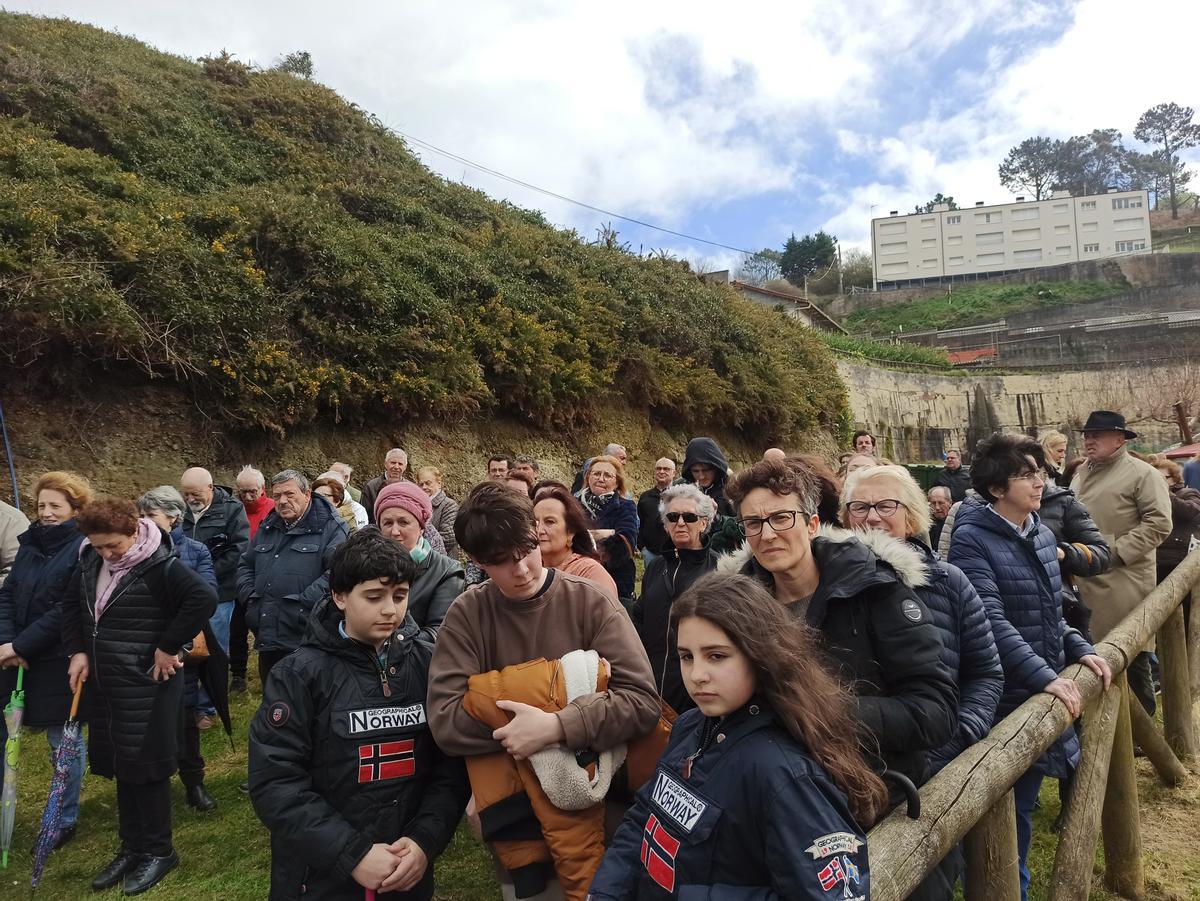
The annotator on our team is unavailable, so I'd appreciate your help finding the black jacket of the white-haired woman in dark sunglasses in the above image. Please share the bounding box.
[630,545,720,713]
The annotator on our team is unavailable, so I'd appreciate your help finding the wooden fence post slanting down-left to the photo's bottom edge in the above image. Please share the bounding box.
[1050,686,1121,901]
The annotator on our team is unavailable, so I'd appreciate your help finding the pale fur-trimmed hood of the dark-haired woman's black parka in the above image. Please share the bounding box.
[716,523,929,596]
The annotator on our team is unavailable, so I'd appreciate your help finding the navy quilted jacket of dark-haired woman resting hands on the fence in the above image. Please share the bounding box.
[950,497,1094,779]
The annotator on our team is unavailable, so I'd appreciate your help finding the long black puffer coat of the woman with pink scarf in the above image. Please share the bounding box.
[62,533,217,783]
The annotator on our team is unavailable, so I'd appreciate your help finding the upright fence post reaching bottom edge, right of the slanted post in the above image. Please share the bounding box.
[1100,672,1146,899]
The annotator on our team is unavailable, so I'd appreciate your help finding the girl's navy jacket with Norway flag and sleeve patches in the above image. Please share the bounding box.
[588,701,871,901]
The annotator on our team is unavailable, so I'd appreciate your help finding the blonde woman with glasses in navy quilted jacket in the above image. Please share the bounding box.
[841,464,1004,773]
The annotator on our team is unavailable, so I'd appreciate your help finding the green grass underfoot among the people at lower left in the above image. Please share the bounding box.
[0,661,500,901]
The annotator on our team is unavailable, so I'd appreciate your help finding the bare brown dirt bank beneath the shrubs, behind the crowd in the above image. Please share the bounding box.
[0,385,833,513]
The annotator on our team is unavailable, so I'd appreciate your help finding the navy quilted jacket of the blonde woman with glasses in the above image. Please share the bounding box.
[908,541,1004,773]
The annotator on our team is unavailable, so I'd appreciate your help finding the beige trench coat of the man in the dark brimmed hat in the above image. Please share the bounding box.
[1070,449,1171,641]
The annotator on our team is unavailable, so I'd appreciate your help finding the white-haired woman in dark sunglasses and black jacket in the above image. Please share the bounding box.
[630,482,720,713]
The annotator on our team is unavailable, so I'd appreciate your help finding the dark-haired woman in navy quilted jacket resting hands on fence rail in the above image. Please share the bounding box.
[949,434,1112,901]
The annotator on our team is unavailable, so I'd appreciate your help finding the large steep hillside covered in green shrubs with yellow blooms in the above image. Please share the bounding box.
[0,13,846,439]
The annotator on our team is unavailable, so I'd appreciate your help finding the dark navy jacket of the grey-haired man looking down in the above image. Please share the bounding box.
[238,494,347,651]
